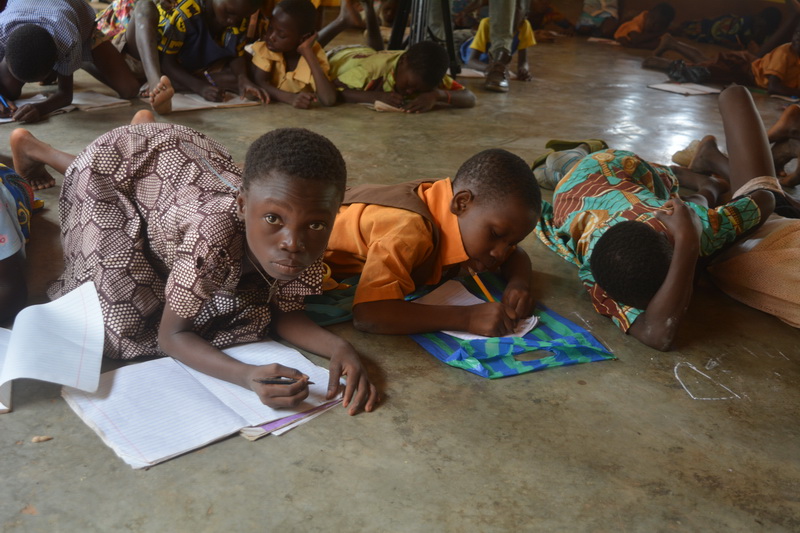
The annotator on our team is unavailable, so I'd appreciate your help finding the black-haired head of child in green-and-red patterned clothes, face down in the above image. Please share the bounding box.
[589,220,672,309]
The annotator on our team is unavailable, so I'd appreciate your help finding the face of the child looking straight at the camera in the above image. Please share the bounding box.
[237,172,341,281]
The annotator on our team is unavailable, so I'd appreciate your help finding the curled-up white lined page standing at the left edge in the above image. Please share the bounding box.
[0,282,104,391]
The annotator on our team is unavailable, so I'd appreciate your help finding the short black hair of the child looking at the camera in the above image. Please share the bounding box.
[242,128,347,200]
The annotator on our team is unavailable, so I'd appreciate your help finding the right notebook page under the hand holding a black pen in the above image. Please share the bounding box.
[178,340,329,427]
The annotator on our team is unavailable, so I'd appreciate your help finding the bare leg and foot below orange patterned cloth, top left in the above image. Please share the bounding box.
[97,0,175,115]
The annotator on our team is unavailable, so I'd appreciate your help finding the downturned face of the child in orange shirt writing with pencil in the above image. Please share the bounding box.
[450,191,539,271]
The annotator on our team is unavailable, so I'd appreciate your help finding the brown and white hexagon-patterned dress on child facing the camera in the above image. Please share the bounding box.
[48,124,322,359]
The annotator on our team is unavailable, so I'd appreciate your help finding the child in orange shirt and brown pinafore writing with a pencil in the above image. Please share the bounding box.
[325,149,541,336]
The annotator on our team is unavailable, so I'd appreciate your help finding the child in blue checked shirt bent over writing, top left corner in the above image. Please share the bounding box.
[0,0,139,125]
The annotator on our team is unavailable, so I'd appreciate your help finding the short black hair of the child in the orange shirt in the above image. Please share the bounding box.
[453,148,542,216]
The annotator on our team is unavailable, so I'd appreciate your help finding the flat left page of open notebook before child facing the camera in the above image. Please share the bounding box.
[62,357,245,468]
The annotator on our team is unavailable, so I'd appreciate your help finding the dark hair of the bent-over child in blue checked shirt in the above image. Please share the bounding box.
[6,24,58,83]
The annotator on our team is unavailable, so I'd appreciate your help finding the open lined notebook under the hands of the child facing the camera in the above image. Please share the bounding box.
[62,341,339,468]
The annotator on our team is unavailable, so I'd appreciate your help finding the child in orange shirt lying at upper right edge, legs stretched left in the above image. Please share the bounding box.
[642,25,800,96]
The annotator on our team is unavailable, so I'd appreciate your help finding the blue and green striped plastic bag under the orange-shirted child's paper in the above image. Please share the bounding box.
[306,274,615,379]
